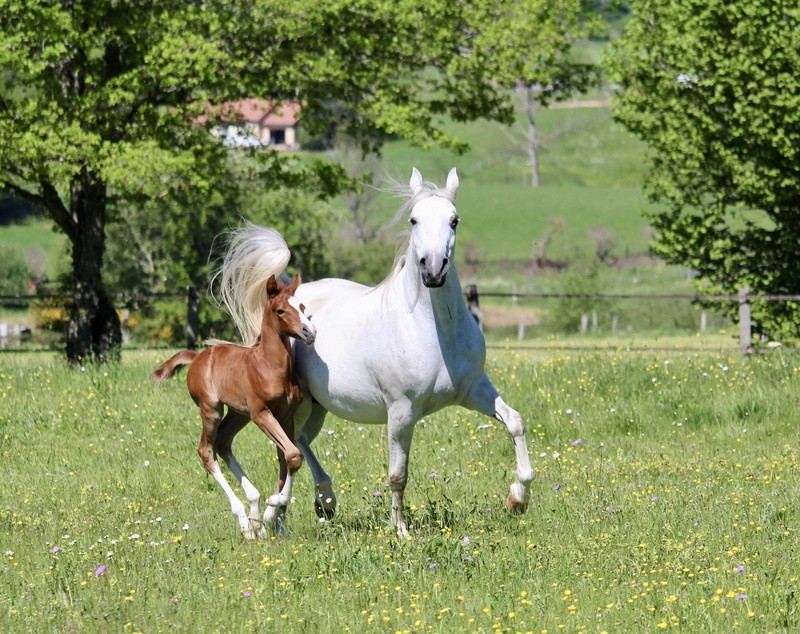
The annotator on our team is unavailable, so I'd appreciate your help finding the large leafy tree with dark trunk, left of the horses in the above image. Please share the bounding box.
[0,0,510,362]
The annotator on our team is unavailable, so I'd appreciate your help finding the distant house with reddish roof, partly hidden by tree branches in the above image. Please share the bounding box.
[197,98,300,150]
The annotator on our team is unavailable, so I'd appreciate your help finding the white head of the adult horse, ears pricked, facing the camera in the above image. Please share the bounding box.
[409,167,458,288]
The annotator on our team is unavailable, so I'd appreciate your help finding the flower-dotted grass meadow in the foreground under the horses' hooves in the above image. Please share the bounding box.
[0,347,800,632]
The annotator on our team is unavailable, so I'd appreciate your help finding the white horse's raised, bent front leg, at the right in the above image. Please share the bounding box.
[463,374,536,513]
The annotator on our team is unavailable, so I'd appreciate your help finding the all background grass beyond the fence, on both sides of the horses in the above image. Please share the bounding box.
[0,102,692,339]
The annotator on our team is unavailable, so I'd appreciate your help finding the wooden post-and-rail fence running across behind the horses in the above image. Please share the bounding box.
[0,284,800,355]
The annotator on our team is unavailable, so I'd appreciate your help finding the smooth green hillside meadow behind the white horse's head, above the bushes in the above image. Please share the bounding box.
[373,103,651,270]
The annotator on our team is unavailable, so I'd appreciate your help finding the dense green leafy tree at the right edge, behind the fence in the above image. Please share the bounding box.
[609,0,800,338]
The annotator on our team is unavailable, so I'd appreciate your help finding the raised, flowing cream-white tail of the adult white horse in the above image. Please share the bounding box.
[215,222,291,345]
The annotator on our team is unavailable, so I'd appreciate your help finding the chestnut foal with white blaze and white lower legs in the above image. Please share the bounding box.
[151,275,316,539]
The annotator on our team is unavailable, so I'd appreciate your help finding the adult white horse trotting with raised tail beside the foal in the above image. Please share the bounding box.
[221,168,534,538]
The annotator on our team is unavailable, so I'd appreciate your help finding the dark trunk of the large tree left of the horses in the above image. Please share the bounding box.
[66,168,122,363]
